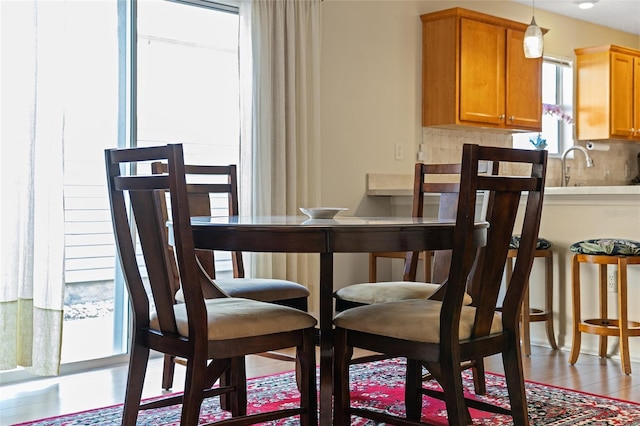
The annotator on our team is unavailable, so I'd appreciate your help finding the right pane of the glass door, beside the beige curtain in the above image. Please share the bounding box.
[136,1,240,277]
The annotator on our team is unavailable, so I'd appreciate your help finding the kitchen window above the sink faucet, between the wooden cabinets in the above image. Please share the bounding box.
[513,57,574,154]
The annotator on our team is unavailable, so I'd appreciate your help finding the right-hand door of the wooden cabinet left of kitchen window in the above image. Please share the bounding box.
[506,30,542,131]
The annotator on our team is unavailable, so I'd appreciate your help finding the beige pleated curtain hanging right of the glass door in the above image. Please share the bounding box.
[240,0,321,306]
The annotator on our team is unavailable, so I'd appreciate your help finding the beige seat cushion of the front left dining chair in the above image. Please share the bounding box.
[150,298,317,340]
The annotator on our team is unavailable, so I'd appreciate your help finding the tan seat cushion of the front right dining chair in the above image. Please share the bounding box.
[334,299,502,343]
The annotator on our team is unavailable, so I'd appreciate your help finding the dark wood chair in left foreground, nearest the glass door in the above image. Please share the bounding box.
[105,145,317,426]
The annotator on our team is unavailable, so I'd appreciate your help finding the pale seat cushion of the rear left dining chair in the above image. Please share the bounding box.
[176,278,309,302]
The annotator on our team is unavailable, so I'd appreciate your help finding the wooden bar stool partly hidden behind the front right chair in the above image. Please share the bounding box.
[506,235,558,356]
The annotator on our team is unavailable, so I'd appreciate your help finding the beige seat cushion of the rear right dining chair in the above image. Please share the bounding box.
[336,281,472,305]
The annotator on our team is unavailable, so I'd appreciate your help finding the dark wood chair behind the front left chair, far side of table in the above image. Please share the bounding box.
[151,161,309,389]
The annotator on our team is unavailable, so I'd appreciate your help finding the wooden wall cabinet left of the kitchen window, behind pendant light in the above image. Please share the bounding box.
[421,8,542,132]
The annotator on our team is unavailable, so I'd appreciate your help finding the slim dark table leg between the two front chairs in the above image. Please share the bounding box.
[320,253,333,426]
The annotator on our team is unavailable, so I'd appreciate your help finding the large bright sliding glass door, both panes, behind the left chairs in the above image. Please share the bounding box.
[62,0,240,363]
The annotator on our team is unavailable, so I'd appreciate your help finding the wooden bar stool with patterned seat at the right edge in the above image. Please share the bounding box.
[569,239,640,374]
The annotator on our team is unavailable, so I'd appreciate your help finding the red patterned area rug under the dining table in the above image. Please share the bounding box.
[13,359,640,426]
